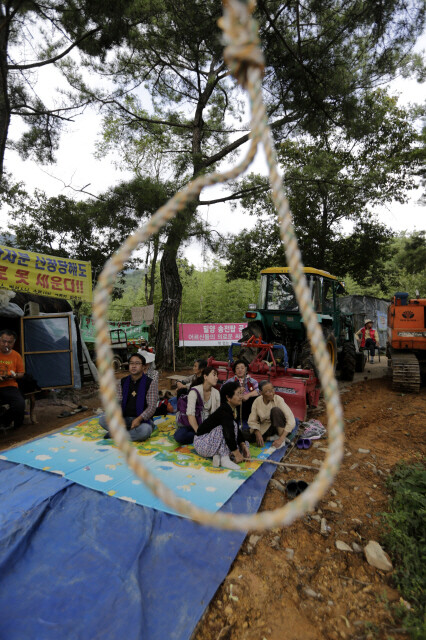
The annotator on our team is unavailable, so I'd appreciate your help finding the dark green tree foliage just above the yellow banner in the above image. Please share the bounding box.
[4,178,172,297]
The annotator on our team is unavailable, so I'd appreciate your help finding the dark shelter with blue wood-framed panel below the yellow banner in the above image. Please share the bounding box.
[0,291,89,389]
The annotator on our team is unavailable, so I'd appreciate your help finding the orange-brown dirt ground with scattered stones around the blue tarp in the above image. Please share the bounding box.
[0,357,426,640]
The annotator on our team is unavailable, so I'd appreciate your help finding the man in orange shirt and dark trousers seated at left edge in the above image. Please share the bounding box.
[0,329,25,429]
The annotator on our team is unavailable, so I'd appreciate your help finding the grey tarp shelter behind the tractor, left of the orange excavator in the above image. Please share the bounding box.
[339,296,390,347]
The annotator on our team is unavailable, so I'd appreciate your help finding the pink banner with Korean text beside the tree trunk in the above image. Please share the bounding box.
[179,322,247,347]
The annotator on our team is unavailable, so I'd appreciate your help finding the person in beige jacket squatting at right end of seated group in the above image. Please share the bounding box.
[248,380,296,449]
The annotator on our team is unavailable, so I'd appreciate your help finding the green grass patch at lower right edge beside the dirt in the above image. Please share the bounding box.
[382,462,426,640]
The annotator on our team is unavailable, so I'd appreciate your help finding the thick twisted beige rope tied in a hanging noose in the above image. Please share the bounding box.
[93,0,343,531]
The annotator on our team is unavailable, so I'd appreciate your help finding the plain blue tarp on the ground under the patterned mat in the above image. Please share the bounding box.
[0,449,284,640]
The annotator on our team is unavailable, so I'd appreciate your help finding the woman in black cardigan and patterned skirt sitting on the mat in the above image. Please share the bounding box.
[194,382,250,469]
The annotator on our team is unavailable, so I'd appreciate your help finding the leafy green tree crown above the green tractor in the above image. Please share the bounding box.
[225,89,423,287]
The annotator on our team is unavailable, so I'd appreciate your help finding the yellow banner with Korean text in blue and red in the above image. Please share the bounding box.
[0,245,92,302]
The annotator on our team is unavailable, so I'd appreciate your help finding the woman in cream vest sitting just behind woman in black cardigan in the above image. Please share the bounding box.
[174,367,220,444]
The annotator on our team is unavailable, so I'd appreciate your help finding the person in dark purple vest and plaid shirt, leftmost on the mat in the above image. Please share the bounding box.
[99,353,158,442]
